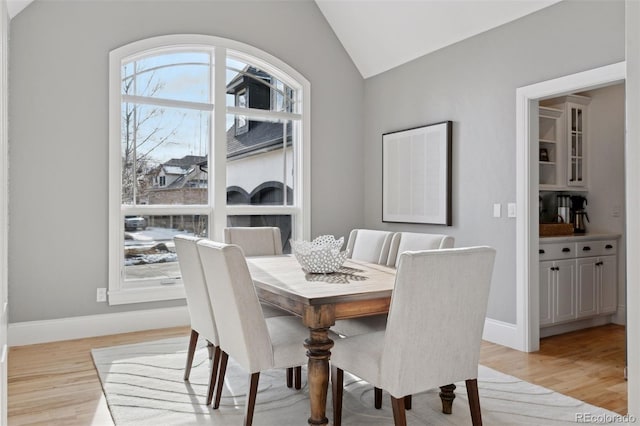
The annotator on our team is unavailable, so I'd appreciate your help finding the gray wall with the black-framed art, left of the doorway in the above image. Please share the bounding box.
[364,1,625,323]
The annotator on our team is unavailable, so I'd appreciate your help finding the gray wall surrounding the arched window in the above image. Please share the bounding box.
[9,0,364,322]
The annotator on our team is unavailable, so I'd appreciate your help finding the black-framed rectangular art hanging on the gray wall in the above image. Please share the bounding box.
[382,121,453,226]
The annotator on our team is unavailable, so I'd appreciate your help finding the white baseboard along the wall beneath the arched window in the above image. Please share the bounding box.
[7,306,190,346]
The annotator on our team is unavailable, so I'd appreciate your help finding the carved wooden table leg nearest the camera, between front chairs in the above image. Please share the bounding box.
[303,306,335,425]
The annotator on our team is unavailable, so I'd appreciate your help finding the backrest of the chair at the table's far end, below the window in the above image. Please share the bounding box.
[224,226,282,256]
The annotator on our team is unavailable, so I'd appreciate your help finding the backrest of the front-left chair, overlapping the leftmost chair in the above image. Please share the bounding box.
[198,240,273,373]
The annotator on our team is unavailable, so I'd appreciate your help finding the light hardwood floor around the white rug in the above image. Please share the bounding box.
[8,325,627,426]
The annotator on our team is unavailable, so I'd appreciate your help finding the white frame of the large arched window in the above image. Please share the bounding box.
[108,34,311,305]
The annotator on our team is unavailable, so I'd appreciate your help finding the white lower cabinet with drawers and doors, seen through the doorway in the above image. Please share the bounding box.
[539,238,618,327]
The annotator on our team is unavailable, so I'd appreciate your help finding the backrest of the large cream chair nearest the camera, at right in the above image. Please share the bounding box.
[381,247,495,397]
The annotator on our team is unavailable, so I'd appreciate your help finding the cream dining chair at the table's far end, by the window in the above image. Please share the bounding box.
[224,226,302,389]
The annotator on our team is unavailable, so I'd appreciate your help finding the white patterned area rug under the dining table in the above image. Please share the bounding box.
[92,336,623,426]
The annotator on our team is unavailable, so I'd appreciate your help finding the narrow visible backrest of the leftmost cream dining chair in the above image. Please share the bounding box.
[173,235,219,346]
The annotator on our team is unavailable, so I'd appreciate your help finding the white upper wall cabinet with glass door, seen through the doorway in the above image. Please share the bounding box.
[538,95,591,191]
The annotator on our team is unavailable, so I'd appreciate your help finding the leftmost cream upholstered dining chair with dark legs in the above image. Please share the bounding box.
[173,235,220,405]
